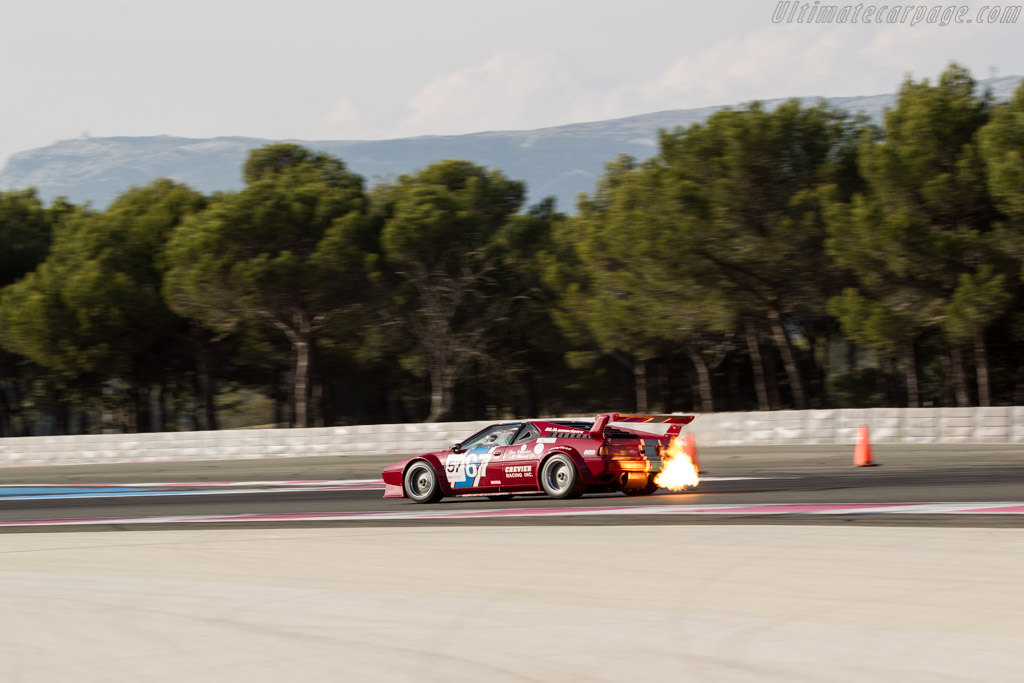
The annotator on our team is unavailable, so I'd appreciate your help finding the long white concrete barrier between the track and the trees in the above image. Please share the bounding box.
[0,405,1024,467]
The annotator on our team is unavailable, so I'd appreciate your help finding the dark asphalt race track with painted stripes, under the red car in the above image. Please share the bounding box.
[0,445,1024,532]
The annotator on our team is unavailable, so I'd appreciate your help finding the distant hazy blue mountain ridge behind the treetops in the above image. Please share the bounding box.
[0,76,1021,212]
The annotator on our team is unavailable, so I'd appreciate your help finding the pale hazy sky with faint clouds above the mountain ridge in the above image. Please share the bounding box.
[0,0,1024,161]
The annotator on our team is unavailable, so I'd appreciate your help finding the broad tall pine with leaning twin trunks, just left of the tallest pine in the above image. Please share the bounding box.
[660,100,862,409]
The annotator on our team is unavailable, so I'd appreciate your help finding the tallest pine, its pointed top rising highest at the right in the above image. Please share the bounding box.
[828,65,1004,407]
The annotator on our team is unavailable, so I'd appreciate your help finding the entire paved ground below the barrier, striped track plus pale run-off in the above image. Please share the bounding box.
[0,445,1024,683]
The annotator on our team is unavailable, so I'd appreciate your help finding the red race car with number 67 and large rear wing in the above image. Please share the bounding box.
[383,413,693,503]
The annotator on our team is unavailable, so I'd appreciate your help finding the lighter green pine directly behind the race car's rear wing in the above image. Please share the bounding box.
[548,157,735,412]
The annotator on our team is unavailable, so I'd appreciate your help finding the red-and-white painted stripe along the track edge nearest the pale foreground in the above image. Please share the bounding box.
[0,502,1024,527]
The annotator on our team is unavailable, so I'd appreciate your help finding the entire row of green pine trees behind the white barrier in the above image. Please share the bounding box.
[6,65,1024,435]
